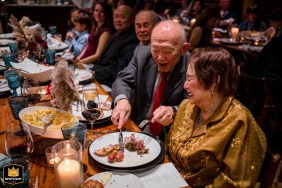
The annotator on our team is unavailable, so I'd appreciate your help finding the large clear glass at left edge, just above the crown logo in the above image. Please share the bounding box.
[5,121,34,157]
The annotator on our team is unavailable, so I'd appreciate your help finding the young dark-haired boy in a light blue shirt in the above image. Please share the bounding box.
[70,12,91,57]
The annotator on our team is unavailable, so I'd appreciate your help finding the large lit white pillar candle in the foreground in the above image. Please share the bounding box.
[58,160,83,188]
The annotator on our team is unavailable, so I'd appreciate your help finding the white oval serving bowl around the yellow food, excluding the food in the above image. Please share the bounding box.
[19,106,78,139]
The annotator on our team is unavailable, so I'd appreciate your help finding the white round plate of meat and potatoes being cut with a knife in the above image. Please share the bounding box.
[89,132,161,168]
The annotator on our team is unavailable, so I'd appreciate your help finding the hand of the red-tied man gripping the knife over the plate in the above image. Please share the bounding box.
[111,99,131,129]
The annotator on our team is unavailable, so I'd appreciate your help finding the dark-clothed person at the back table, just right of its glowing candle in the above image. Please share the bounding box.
[239,4,266,31]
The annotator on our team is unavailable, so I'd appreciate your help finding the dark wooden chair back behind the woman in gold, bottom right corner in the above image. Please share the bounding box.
[258,151,281,188]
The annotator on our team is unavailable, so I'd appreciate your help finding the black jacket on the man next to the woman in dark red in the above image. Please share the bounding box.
[93,26,139,87]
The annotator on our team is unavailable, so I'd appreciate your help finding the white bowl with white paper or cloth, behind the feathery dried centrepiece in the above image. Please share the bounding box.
[11,58,54,83]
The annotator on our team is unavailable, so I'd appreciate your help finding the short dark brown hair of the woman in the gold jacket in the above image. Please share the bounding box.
[188,47,239,96]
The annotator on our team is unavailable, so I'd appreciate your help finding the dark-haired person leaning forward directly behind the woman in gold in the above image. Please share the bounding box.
[188,7,220,51]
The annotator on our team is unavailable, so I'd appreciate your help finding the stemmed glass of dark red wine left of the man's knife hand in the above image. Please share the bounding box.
[81,88,101,130]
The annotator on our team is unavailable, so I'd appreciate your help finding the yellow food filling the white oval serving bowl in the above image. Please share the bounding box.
[22,109,75,130]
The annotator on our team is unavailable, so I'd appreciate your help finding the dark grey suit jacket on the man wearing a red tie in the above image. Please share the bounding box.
[112,46,187,124]
